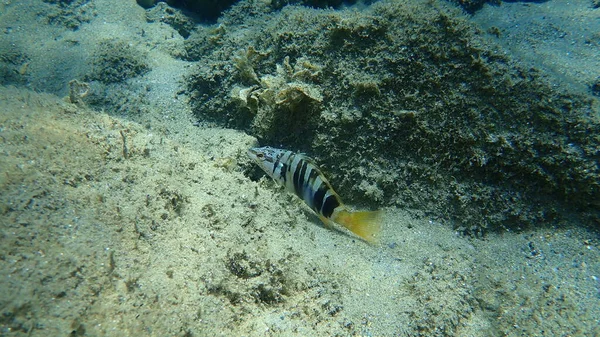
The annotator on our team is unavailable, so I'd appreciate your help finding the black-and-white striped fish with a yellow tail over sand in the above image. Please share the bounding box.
[248,147,381,243]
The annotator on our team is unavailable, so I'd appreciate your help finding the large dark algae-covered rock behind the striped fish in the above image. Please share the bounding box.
[186,1,600,234]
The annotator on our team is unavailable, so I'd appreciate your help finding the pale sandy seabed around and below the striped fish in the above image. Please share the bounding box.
[0,0,600,336]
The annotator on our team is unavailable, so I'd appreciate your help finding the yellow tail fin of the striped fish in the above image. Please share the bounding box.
[332,209,382,243]
